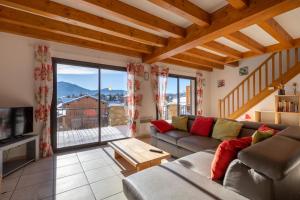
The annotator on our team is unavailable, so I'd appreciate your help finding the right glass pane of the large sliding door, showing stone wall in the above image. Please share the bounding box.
[100,69,129,142]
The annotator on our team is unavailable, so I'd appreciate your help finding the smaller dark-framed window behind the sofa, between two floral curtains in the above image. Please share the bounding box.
[163,75,196,120]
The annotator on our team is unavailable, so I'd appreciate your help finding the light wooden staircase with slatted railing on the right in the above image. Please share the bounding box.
[218,48,300,119]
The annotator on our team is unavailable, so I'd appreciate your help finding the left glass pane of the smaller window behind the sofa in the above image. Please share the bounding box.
[164,77,178,120]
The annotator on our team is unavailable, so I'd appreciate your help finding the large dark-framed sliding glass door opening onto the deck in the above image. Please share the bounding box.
[52,59,129,149]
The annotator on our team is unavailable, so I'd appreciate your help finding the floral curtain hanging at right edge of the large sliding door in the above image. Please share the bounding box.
[127,63,144,137]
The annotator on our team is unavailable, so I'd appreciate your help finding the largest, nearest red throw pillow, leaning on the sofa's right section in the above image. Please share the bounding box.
[210,137,252,180]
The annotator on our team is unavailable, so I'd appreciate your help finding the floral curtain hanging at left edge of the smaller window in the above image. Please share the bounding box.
[150,65,169,119]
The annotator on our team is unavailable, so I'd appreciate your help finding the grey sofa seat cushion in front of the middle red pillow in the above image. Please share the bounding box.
[177,135,221,152]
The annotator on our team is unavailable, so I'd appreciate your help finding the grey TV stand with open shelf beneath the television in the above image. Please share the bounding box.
[0,134,39,181]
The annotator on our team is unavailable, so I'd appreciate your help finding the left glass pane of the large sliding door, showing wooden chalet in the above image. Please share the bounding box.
[56,64,99,148]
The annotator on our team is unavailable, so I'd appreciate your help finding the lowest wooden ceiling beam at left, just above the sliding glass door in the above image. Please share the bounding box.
[0,21,141,57]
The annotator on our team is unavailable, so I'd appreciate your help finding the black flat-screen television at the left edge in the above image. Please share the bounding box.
[0,107,33,140]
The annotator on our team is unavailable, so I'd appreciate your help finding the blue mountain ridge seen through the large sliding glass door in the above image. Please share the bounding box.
[57,81,126,98]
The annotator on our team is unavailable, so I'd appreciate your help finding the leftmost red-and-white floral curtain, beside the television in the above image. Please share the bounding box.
[34,45,53,157]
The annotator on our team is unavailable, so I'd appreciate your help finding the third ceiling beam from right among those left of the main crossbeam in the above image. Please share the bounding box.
[80,0,185,38]
